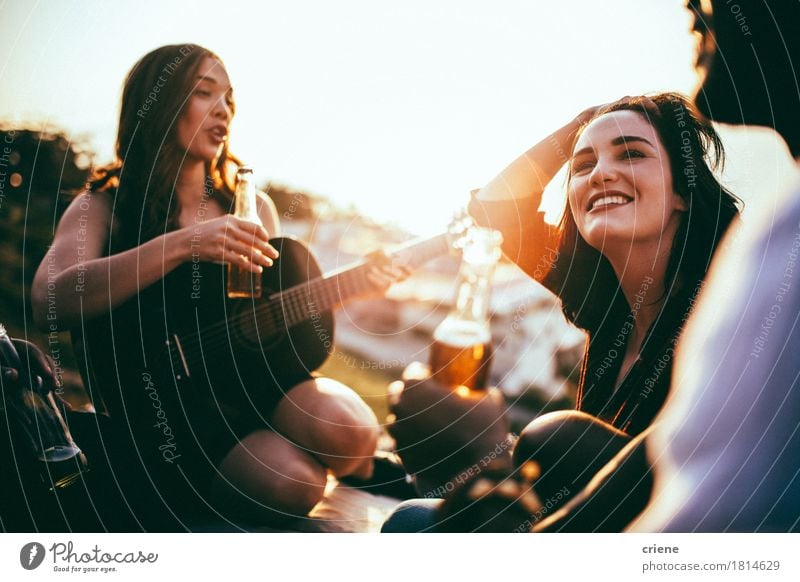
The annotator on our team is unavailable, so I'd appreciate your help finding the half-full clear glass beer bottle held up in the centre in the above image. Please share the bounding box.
[430,227,503,390]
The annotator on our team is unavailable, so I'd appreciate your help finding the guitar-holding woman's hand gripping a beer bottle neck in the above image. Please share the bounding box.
[186,214,278,273]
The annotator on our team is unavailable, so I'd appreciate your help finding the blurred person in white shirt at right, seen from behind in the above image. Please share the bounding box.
[385,0,800,532]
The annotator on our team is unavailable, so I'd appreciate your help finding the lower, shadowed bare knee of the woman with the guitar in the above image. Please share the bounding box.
[211,430,327,521]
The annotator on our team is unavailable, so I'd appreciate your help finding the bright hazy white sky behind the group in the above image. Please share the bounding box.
[0,0,788,233]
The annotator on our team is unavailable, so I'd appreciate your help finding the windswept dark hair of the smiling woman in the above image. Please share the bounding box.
[547,93,739,333]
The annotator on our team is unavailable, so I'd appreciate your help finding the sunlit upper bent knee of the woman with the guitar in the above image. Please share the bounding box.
[272,378,380,479]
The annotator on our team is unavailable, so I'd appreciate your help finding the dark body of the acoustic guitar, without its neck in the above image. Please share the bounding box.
[73,238,334,419]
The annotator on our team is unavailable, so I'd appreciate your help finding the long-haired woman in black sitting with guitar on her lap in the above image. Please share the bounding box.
[32,44,396,521]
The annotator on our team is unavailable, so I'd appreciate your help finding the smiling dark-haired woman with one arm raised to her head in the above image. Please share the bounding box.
[471,93,737,434]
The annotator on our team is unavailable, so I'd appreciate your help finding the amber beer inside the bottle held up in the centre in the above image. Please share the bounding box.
[430,322,492,390]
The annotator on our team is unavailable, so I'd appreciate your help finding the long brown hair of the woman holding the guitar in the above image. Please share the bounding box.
[89,44,239,246]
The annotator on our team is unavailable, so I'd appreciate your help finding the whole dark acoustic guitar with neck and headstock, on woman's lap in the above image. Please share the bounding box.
[72,228,451,460]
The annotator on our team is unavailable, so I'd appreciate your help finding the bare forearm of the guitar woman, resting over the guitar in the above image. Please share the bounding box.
[32,231,190,330]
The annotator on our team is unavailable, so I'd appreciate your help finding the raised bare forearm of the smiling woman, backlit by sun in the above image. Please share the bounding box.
[476,114,585,207]
